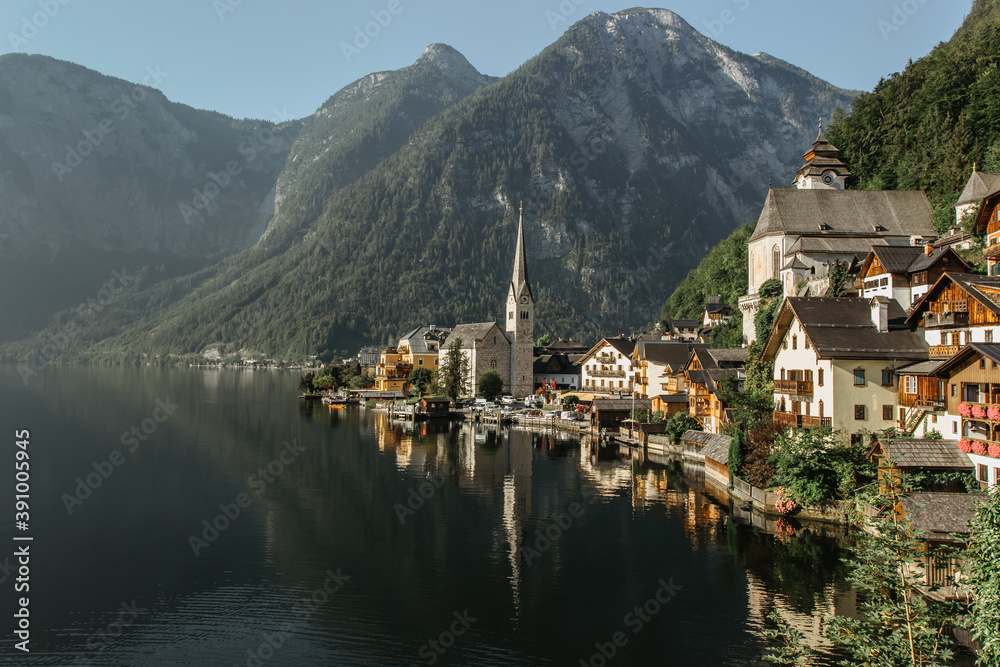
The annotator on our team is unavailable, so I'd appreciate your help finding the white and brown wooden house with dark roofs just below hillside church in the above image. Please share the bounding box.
[856,245,969,310]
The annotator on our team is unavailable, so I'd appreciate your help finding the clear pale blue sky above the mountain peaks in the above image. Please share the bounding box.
[0,0,971,119]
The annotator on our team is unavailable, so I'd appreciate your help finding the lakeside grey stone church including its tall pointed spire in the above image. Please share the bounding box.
[439,207,535,398]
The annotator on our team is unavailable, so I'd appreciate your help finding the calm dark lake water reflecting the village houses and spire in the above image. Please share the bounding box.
[0,367,853,667]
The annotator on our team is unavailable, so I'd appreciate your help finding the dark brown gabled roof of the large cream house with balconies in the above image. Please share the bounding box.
[762,296,929,361]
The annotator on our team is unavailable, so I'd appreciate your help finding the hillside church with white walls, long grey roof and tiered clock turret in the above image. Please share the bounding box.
[739,132,937,342]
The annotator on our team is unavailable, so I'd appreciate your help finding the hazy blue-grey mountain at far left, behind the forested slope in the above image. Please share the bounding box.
[0,54,299,339]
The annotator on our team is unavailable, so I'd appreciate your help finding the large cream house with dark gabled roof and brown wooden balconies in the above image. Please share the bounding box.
[762,297,927,439]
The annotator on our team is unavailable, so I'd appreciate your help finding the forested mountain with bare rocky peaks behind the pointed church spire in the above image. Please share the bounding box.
[3,9,853,366]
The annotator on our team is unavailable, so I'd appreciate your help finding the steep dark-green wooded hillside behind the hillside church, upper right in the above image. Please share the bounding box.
[827,0,1000,232]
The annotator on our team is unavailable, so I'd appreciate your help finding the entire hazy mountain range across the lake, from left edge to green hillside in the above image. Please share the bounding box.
[0,9,853,360]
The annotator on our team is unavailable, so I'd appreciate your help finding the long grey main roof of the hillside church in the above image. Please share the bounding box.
[750,189,937,241]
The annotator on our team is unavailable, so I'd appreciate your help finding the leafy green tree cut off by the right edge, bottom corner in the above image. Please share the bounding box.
[966,486,1000,667]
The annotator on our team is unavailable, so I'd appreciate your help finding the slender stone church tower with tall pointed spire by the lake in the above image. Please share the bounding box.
[505,204,535,398]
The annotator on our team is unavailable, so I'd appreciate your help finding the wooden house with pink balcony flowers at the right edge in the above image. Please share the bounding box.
[938,343,1000,487]
